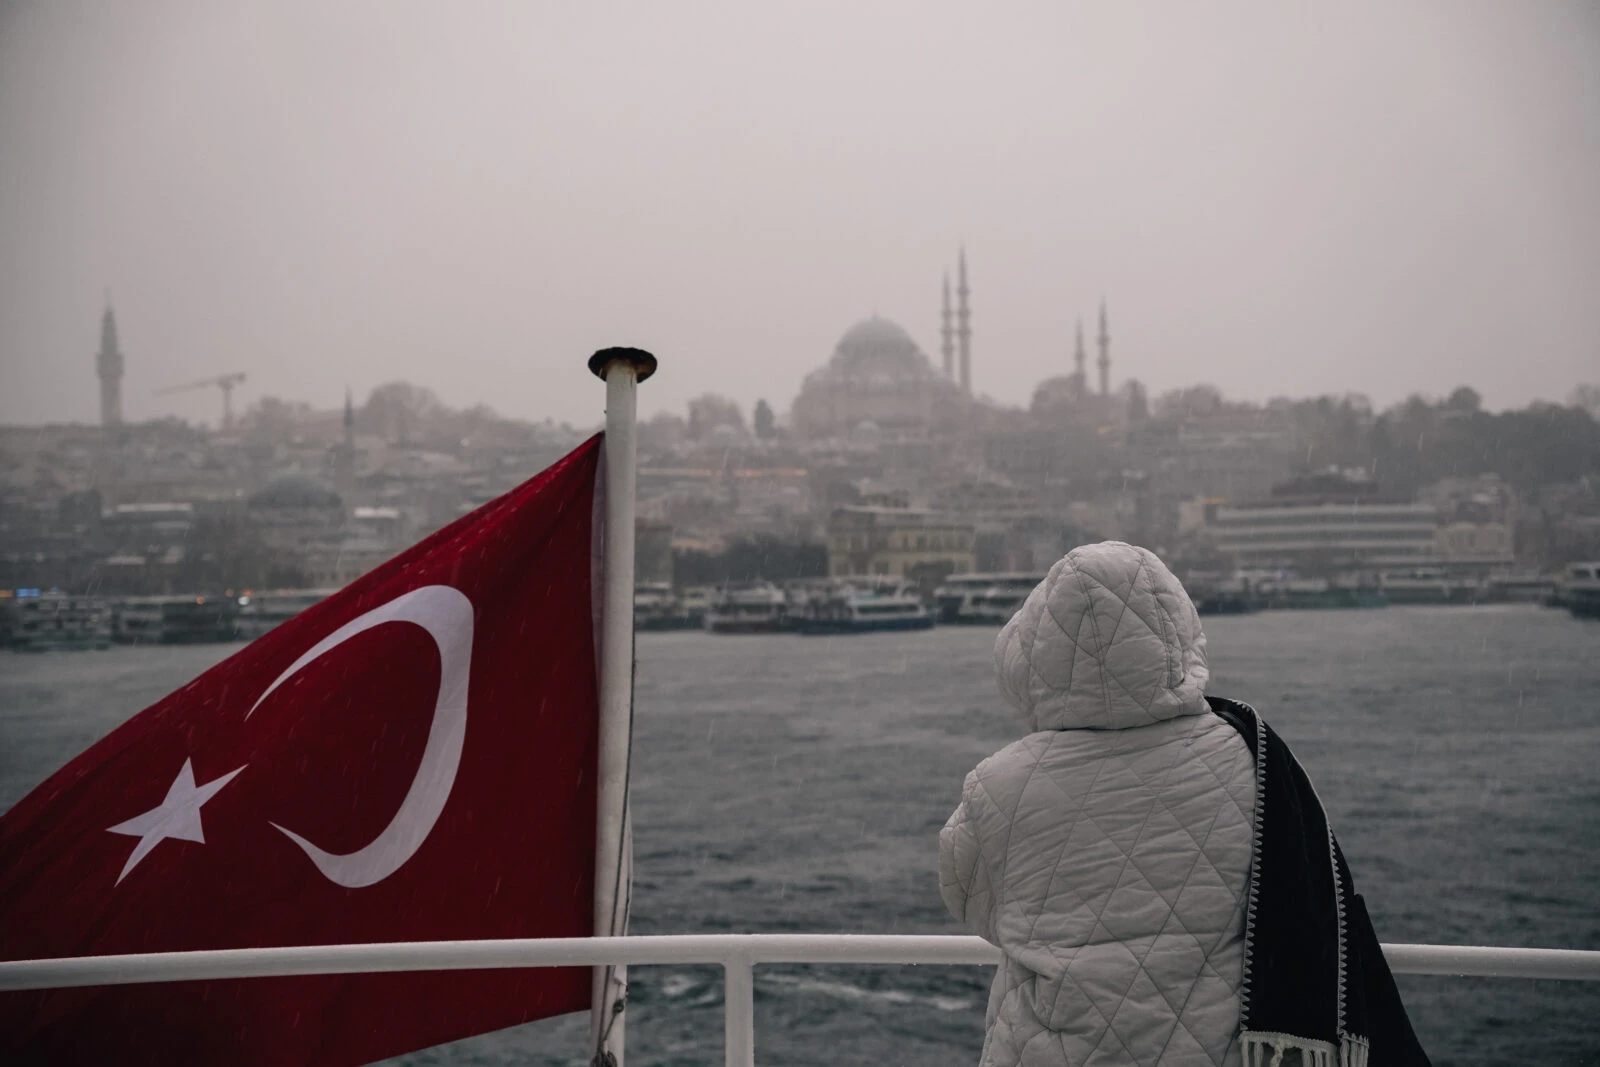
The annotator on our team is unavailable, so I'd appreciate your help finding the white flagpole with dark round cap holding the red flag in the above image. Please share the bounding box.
[589,349,656,1067]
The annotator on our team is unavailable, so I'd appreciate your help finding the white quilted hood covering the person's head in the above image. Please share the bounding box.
[995,541,1211,733]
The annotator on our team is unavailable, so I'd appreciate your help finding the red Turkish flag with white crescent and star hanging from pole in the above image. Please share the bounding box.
[0,435,602,1064]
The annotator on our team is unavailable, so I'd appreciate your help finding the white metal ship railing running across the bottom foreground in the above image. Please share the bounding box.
[0,934,1600,1067]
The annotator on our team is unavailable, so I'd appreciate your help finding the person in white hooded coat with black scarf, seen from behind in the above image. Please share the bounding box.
[939,542,1426,1067]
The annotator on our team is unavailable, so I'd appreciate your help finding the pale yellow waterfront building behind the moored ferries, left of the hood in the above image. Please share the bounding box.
[827,507,976,577]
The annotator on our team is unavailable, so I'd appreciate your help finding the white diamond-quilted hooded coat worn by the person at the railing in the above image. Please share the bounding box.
[939,541,1254,1067]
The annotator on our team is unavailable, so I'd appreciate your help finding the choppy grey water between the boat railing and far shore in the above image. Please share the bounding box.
[0,606,1600,1067]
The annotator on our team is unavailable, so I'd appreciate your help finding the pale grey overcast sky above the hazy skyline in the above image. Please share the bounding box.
[0,0,1600,424]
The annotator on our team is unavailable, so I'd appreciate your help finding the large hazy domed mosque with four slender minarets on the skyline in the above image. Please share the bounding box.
[790,248,1123,438]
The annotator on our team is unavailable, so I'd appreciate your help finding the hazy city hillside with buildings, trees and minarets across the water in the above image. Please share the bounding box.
[0,292,1600,620]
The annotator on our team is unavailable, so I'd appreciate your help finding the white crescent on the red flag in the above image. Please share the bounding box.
[245,585,472,889]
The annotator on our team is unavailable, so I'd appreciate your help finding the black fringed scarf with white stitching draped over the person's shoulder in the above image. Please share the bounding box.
[1206,696,1429,1067]
